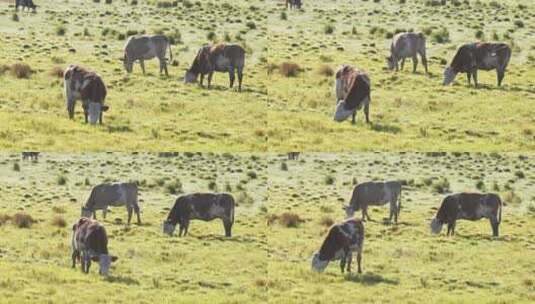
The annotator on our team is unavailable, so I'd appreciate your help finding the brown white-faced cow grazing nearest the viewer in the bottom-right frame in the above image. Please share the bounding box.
[312,219,364,273]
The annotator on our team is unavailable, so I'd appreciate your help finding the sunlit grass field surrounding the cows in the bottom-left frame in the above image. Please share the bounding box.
[0,153,267,303]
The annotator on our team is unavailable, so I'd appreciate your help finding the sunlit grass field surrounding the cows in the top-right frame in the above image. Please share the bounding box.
[267,0,535,152]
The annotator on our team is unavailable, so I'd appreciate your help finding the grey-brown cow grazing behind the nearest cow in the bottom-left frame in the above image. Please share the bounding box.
[82,183,141,225]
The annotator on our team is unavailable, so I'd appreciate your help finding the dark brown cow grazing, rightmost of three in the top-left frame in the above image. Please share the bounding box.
[184,44,245,91]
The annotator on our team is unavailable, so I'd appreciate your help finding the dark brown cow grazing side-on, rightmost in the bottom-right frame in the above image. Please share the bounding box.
[431,193,502,236]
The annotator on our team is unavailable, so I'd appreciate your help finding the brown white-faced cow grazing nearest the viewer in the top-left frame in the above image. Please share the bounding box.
[63,65,109,124]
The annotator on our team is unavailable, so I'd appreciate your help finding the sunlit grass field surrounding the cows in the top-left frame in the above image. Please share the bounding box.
[0,0,267,152]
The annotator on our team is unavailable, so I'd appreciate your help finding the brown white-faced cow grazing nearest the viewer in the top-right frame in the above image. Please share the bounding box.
[334,65,371,124]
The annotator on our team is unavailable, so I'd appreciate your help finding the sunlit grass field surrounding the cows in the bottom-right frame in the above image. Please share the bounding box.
[268,153,535,303]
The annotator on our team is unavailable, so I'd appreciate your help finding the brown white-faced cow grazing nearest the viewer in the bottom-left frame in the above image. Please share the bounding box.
[72,217,117,275]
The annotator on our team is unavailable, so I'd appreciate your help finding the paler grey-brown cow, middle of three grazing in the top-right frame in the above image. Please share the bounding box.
[386,33,428,73]
